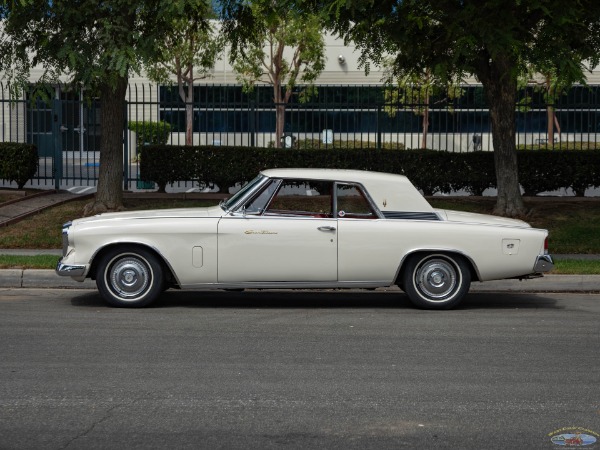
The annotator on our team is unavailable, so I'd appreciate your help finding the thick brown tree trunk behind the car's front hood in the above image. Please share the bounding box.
[83,77,127,216]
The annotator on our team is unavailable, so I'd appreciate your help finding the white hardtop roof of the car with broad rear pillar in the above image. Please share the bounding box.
[261,169,433,212]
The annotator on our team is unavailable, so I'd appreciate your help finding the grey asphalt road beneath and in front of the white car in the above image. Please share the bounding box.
[0,289,600,449]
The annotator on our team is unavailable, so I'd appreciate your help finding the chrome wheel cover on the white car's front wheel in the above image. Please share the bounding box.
[105,255,153,301]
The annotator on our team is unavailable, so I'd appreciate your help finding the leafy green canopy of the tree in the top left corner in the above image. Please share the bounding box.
[0,0,211,90]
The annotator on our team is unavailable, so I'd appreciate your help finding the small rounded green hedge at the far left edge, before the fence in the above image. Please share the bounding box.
[0,142,38,189]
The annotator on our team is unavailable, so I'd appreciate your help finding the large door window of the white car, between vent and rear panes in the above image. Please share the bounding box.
[265,180,333,217]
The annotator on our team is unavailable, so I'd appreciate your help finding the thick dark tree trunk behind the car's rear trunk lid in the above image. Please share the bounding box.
[477,55,526,217]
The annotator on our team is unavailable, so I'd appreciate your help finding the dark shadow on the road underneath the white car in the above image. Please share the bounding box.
[71,290,563,311]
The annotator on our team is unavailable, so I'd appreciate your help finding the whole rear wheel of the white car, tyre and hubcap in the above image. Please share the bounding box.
[400,253,471,309]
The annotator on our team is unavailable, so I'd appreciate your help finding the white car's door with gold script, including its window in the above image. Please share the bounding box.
[218,180,337,283]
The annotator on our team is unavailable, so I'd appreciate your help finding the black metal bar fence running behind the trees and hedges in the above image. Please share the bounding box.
[0,84,600,189]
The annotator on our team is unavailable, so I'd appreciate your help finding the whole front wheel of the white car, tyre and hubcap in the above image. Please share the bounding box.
[96,247,165,308]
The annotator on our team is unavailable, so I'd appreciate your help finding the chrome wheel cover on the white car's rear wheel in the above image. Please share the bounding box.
[414,257,461,302]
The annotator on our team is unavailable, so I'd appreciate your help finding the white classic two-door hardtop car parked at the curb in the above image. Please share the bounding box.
[56,169,553,309]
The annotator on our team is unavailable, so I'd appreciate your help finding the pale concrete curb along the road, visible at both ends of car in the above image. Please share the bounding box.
[0,269,600,293]
